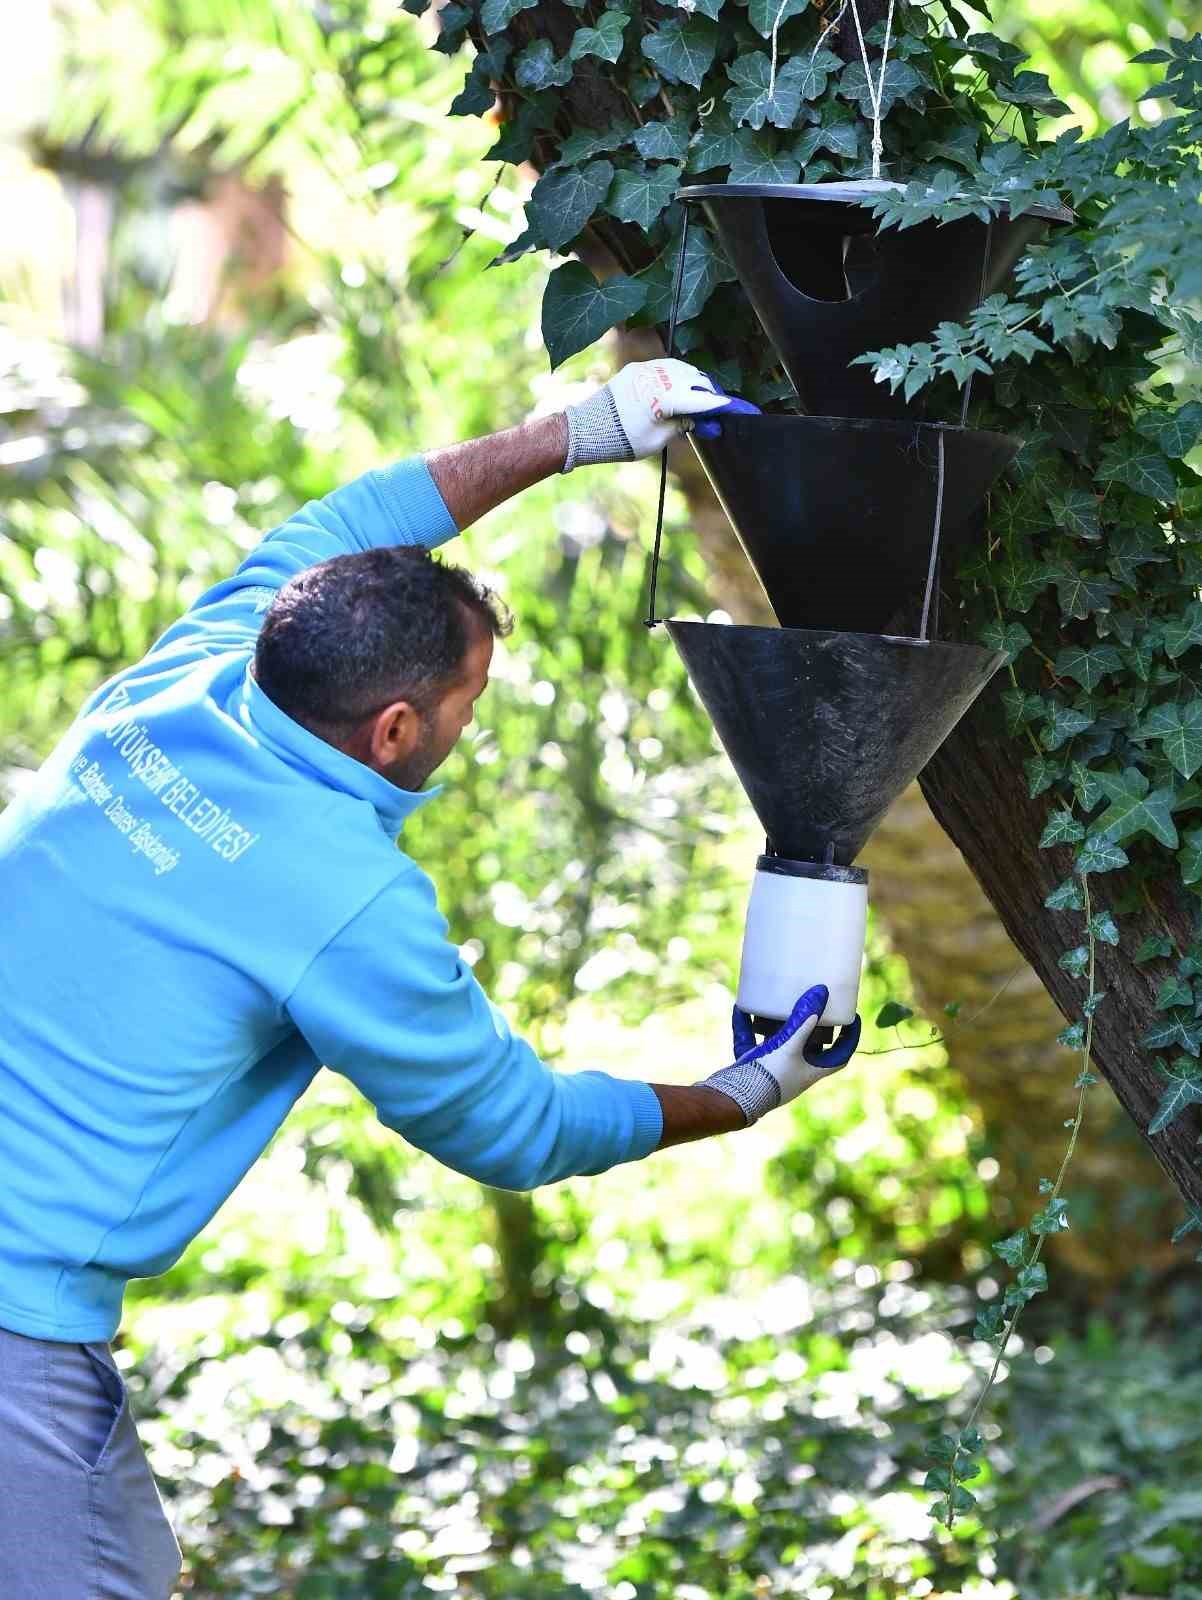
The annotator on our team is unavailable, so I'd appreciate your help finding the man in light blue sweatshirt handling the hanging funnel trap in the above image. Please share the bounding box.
[0,360,853,1600]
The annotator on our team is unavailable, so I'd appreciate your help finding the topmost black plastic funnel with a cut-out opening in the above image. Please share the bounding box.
[677,179,1072,418]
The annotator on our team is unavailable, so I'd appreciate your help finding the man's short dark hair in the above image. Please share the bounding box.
[254,546,512,730]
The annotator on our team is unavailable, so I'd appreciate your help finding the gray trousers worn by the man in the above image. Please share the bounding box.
[0,1328,179,1600]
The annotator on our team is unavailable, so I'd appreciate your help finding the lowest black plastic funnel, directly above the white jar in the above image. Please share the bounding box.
[667,621,1005,866]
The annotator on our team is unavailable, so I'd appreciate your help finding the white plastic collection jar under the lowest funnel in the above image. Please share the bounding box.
[738,856,867,1027]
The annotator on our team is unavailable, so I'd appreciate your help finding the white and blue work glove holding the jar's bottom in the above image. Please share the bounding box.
[699,984,859,1126]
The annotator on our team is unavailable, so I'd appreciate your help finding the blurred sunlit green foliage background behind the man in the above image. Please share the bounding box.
[0,0,1202,1600]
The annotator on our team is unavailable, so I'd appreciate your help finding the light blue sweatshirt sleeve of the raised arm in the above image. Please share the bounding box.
[142,456,459,656]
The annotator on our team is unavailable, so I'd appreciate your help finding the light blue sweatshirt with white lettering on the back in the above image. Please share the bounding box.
[0,461,663,1341]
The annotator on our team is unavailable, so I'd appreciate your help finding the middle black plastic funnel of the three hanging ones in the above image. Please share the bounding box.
[690,416,1021,634]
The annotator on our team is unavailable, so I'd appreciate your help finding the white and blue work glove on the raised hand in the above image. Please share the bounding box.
[563,357,759,472]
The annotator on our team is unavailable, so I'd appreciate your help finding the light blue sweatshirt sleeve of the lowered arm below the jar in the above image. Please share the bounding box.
[288,864,663,1189]
